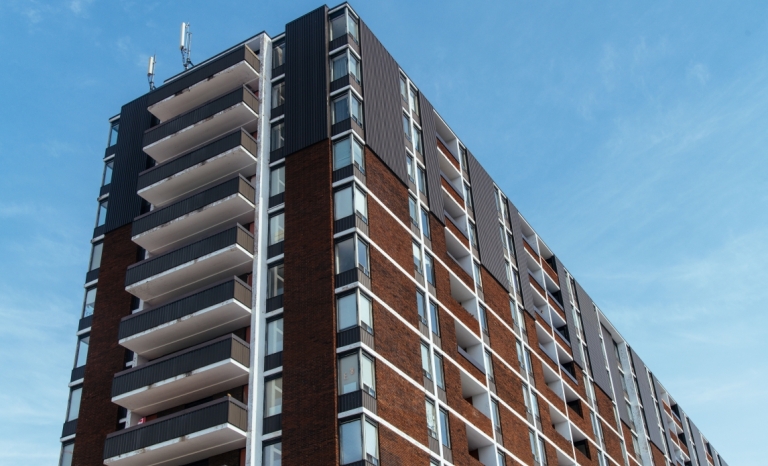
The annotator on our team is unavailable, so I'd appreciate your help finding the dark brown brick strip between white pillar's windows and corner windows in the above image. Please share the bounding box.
[282,140,338,466]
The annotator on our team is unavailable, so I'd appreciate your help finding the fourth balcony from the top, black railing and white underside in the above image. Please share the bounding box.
[131,175,256,254]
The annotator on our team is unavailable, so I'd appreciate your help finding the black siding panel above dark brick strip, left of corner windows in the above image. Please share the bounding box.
[285,6,330,155]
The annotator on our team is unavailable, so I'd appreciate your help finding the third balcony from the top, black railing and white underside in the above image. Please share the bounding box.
[136,129,257,207]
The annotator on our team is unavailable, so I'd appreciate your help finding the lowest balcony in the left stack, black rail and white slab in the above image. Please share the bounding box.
[104,397,248,466]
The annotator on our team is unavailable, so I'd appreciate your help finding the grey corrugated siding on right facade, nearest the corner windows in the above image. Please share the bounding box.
[360,21,408,185]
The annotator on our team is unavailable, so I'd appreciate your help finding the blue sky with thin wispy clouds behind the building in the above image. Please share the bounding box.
[0,0,768,465]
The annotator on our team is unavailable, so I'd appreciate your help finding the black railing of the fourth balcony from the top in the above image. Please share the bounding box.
[131,175,256,236]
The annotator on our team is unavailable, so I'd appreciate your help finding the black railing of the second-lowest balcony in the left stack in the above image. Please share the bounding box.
[112,334,250,397]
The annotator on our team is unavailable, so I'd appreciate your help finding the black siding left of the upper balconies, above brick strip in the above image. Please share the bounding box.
[105,95,152,232]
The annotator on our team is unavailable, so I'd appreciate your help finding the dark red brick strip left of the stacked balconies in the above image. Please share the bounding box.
[72,225,138,466]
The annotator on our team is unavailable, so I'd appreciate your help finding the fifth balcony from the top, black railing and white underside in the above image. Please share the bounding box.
[125,225,253,305]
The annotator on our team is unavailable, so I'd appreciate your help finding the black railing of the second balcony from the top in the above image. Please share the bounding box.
[144,86,259,151]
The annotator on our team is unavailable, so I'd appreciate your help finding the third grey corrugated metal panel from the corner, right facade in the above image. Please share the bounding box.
[467,151,510,290]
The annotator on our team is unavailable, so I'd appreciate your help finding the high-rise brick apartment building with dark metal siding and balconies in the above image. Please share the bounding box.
[60,3,727,466]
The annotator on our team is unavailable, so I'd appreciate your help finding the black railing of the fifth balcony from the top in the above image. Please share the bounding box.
[125,225,253,287]
